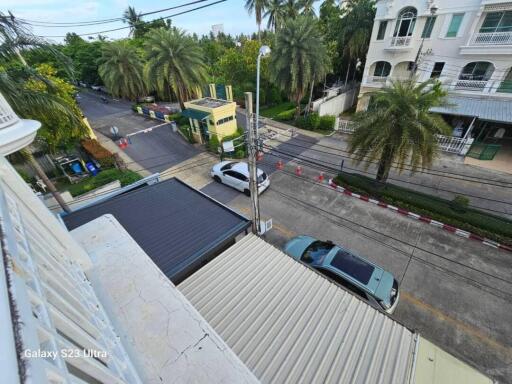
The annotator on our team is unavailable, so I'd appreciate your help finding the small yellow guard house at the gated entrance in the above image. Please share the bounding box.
[182,84,237,144]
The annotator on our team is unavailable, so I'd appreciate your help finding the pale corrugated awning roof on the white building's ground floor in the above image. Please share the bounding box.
[430,96,512,123]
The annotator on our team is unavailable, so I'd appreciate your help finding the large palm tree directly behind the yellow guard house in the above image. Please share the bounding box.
[144,28,207,109]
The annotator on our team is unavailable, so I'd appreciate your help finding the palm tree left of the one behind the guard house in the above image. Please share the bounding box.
[98,41,146,100]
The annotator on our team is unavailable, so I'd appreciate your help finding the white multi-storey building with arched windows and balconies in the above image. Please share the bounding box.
[358,0,512,172]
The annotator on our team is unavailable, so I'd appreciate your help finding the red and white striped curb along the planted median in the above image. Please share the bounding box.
[329,179,512,252]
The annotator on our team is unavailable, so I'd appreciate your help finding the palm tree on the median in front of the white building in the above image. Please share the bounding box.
[348,79,450,181]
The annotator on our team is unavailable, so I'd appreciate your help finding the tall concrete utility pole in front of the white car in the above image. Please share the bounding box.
[245,92,260,234]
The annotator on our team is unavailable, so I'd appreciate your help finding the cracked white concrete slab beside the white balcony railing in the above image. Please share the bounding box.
[72,215,258,384]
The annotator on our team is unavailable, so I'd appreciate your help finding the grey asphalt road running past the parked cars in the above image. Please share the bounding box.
[79,95,512,383]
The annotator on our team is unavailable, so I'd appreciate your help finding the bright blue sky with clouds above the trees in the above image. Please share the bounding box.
[0,0,286,42]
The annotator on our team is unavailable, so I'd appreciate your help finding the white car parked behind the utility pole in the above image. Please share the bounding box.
[211,161,270,196]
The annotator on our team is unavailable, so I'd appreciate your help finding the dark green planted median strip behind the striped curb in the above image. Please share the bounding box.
[334,173,512,245]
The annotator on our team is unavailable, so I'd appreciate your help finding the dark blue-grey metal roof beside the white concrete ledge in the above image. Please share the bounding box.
[63,178,250,283]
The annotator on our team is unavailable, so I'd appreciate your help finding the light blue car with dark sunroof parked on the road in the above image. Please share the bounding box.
[284,236,400,314]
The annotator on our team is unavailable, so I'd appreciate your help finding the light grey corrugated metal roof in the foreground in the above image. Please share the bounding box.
[178,235,415,384]
